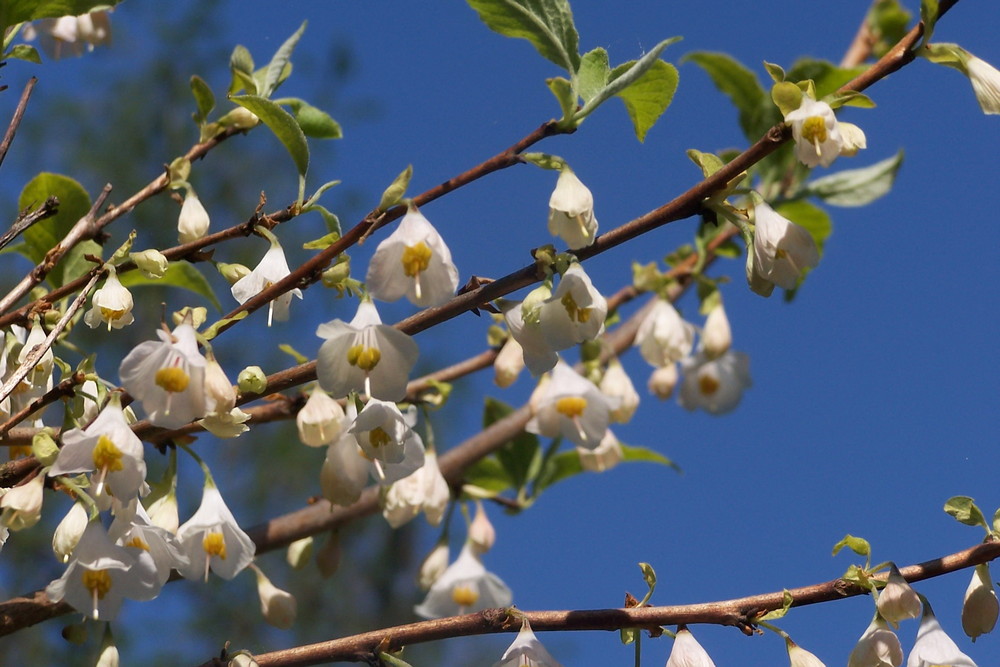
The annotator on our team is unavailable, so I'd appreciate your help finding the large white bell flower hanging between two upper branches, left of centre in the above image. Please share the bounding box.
[365,204,458,307]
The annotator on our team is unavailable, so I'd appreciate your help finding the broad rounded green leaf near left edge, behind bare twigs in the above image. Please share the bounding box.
[17,172,92,287]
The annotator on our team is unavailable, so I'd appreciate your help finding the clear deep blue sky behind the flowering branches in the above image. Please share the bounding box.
[3,0,1000,667]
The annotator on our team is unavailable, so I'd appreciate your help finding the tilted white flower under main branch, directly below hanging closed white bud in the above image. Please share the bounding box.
[538,262,608,350]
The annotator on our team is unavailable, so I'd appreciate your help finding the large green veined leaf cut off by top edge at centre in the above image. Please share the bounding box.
[468,0,580,74]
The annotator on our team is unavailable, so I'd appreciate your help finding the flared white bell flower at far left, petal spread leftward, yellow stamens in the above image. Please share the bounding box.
[49,394,146,503]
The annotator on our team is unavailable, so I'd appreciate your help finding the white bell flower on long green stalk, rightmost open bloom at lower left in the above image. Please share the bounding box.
[177,483,256,581]
